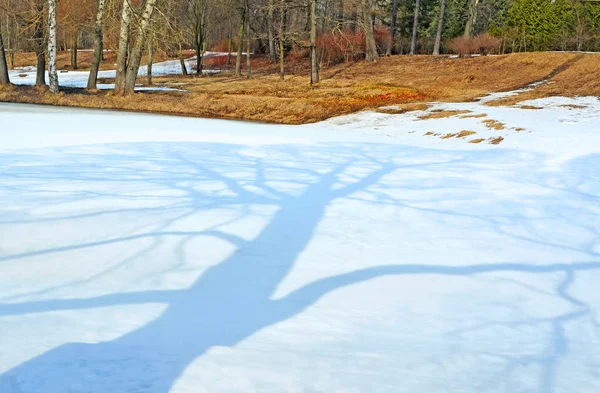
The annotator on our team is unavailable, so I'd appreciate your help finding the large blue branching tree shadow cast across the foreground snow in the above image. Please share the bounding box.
[0,144,600,393]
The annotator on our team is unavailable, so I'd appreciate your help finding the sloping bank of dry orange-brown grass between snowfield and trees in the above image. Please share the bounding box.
[0,52,600,124]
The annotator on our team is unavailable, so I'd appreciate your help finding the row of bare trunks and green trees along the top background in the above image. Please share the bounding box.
[0,0,600,94]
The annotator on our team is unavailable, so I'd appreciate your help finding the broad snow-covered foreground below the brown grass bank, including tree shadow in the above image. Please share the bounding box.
[0,98,600,393]
